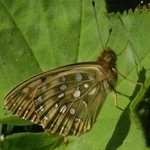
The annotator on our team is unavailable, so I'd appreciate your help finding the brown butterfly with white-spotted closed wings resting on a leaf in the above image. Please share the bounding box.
[4,48,118,136]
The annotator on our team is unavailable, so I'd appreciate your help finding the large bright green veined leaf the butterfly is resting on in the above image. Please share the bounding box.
[0,0,150,150]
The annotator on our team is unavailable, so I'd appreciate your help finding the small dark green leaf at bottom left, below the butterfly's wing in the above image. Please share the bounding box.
[0,133,63,150]
